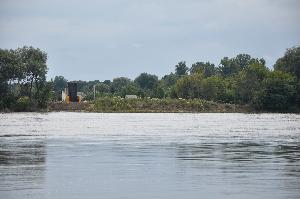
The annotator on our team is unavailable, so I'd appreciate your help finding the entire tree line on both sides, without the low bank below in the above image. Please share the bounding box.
[0,47,300,112]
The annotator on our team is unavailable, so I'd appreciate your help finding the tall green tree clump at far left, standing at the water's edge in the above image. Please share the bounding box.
[0,46,52,111]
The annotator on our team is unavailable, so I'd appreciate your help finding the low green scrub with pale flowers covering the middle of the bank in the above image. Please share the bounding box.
[90,97,247,113]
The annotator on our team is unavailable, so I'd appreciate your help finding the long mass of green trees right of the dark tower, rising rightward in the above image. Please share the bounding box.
[54,47,300,112]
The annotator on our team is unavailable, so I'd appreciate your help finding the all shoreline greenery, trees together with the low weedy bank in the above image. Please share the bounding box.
[0,46,300,112]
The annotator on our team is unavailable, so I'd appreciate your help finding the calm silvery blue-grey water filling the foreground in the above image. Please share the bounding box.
[0,113,300,199]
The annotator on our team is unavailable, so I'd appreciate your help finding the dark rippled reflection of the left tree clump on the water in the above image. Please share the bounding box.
[0,134,46,198]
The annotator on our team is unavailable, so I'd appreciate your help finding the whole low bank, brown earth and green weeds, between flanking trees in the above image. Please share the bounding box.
[49,97,254,113]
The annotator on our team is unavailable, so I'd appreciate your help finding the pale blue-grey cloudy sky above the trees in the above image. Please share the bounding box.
[0,0,300,81]
